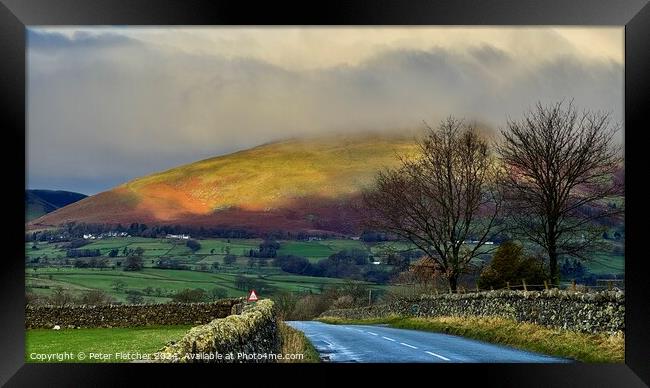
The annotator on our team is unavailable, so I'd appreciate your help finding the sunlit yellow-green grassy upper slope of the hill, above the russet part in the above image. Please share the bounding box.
[127,136,415,209]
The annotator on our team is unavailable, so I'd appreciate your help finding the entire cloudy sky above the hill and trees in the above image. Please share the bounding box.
[26,26,624,194]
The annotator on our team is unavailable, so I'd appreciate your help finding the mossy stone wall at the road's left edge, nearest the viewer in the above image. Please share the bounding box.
[157,299,281,363]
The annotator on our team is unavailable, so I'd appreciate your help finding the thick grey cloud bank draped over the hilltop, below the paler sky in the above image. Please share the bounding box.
[28,33,623,194]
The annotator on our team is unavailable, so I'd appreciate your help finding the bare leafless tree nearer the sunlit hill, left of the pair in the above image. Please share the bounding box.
[363,117,500,292]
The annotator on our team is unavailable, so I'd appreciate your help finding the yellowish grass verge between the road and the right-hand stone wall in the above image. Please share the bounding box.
[318,316,625,363]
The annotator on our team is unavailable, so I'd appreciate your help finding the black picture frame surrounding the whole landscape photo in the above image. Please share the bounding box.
[0,0,650,387]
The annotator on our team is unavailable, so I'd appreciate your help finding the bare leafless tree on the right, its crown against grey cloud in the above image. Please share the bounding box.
[498,102,623,283]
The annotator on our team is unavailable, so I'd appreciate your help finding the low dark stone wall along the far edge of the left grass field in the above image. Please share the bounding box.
[25,298,243,329]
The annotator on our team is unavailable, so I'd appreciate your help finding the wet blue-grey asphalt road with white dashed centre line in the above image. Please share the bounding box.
[287,321,571,363]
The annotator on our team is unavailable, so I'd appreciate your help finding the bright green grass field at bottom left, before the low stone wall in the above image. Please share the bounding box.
[25,325,191,363]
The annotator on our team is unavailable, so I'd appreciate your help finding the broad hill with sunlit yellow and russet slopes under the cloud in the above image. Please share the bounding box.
[30,134,415,233]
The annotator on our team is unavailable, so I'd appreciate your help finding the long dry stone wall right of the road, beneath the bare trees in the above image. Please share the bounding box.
[321,289,625,333]
